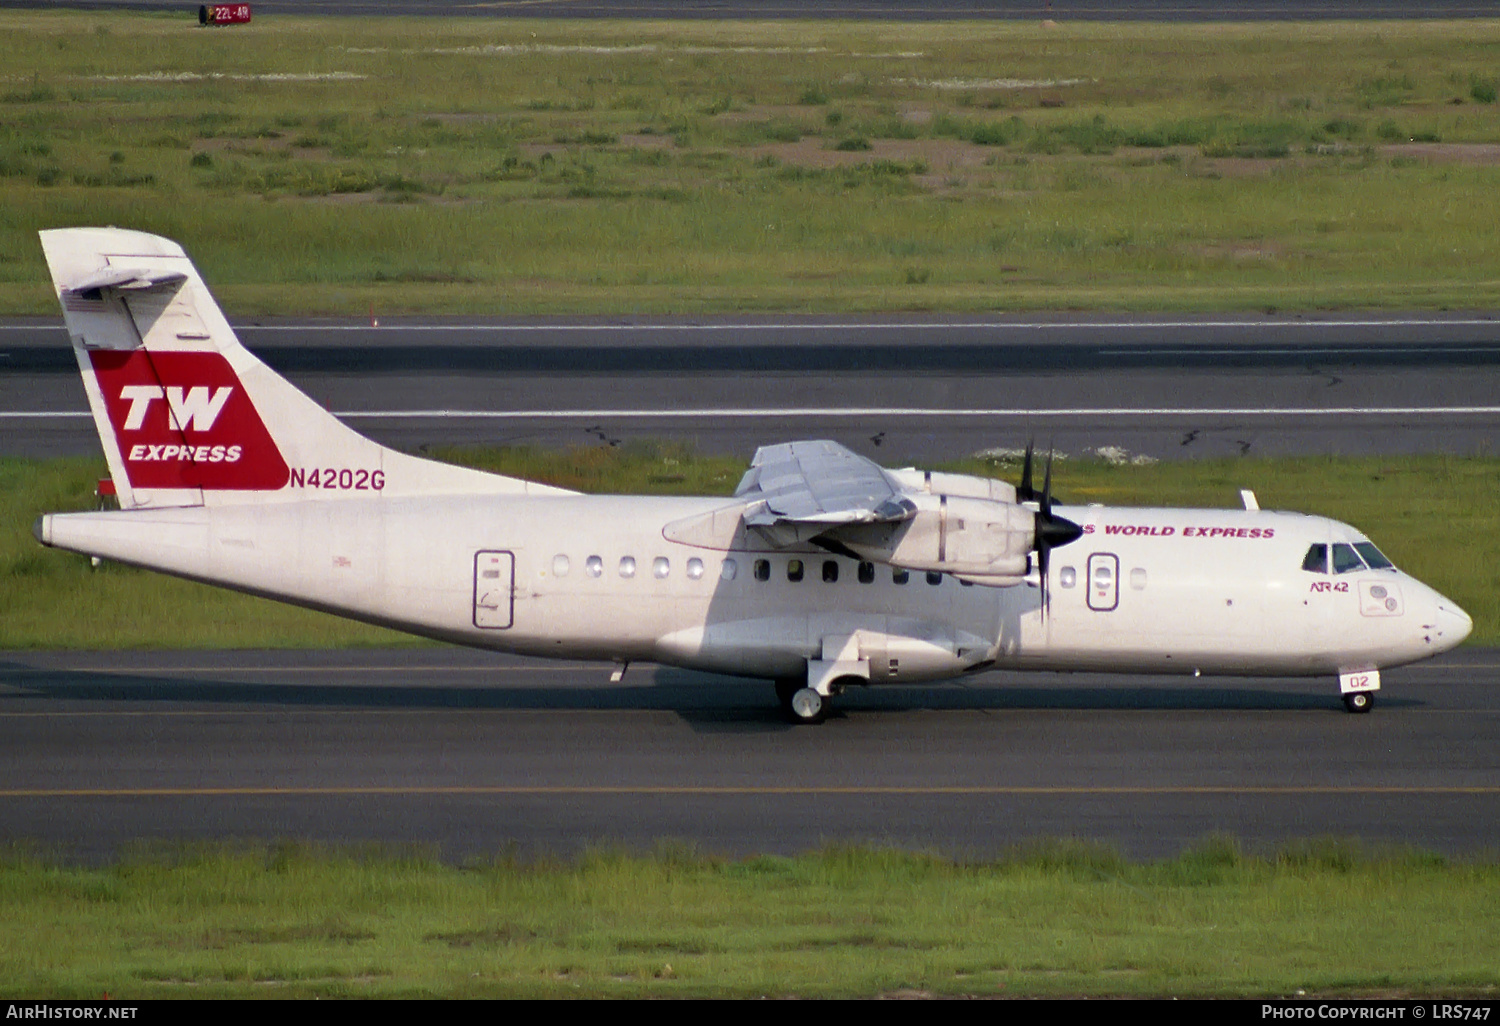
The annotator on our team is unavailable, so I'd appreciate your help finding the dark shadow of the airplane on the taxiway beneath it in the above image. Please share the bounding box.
[0,662,1404,732]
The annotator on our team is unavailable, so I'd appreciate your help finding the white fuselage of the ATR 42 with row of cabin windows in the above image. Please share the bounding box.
[39,495,1470,683]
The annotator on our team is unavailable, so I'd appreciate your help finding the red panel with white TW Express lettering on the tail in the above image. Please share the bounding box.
[89,350,290,491]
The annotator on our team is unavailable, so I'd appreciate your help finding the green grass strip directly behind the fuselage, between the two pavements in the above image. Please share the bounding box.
[0,446,1500,650]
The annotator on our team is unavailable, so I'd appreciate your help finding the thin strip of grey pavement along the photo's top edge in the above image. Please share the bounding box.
[0,0,1497,21]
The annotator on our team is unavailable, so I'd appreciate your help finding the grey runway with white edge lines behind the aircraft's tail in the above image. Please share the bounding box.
[0,312,1500,464]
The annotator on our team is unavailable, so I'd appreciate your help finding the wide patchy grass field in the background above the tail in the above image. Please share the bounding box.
[0,11,1500,315]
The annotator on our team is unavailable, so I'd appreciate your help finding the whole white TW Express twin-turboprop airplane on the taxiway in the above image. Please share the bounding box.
[36,228,1472,722]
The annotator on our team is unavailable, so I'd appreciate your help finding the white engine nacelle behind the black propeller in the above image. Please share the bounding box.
[831,492,1037,584]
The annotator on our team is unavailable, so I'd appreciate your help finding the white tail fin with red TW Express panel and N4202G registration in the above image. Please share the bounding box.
[41,228,563,509]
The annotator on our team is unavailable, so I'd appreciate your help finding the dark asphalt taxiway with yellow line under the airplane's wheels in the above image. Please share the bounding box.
[0,648,1500,861]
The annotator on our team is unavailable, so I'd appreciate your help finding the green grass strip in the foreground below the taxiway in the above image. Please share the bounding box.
[0,839,1500,1001]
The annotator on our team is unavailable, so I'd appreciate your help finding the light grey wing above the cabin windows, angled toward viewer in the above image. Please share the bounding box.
[735,441,917,542]
